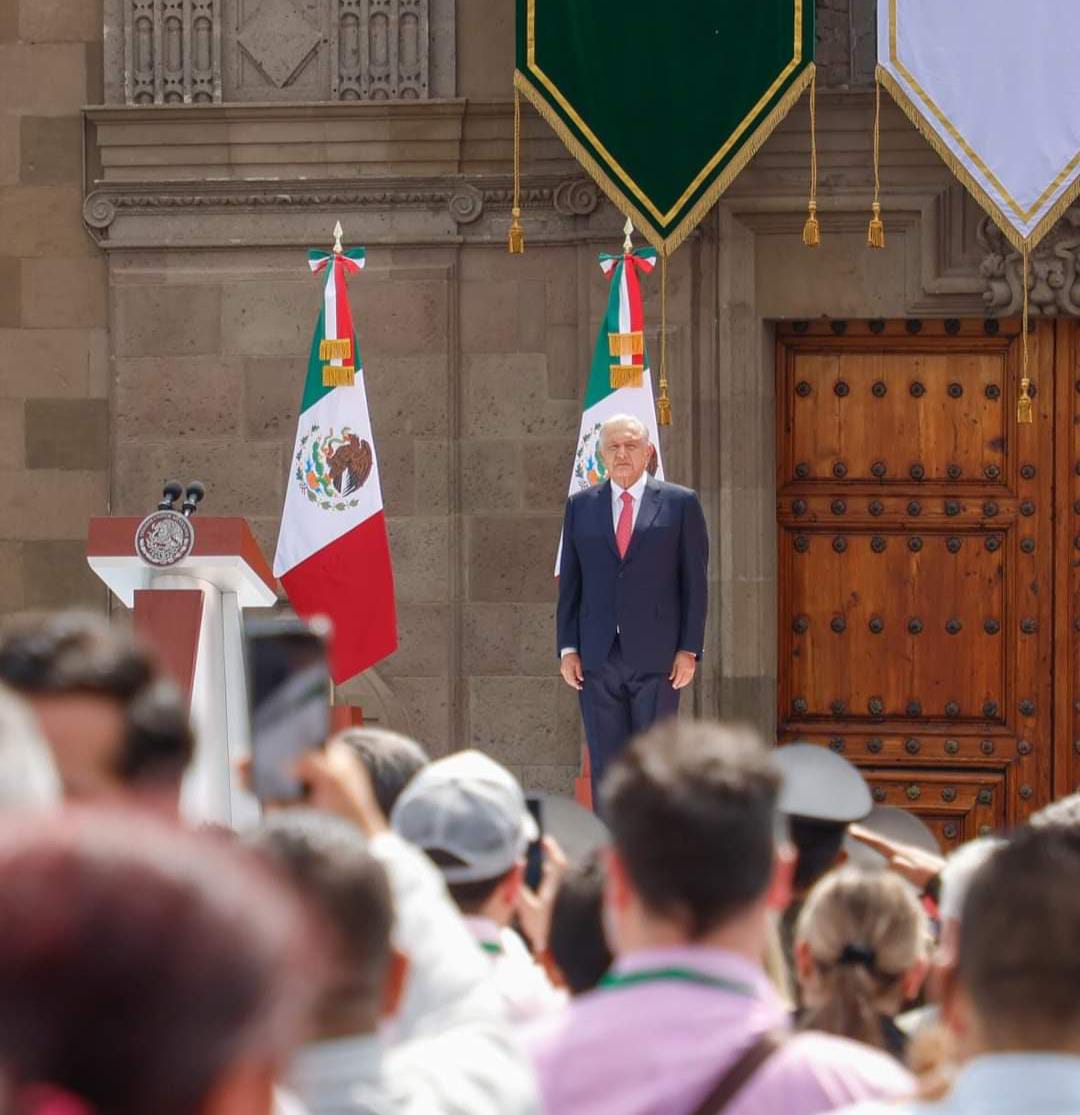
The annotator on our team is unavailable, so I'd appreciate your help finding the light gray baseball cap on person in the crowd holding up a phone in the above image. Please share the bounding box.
[390,750,538,883]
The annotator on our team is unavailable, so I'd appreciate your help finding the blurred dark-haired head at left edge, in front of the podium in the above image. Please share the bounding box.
[0,612,194,812]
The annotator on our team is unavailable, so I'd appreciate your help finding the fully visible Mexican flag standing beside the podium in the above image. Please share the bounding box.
[274,241,398,682]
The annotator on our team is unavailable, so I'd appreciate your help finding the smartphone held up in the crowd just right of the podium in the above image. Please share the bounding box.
[244,619,332,802]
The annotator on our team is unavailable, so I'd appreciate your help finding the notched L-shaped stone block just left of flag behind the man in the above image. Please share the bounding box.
[463,353,580,437]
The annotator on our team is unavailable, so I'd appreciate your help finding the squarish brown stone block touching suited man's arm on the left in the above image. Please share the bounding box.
[466,515,562,603]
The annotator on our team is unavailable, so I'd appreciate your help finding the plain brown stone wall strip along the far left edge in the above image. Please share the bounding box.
[0,0,109,612]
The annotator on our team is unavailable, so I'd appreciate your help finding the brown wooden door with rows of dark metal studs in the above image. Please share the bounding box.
[777,321,1052,846]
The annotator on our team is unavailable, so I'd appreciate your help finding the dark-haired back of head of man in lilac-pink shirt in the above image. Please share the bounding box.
[602,720,794,957]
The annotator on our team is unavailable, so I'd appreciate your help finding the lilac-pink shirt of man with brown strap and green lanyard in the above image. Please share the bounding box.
[525,947,914,1115]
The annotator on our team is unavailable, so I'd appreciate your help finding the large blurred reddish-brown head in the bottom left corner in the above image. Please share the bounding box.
[0,809,319,1115]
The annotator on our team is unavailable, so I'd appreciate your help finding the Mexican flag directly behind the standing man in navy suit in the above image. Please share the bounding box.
[555,248,664,576]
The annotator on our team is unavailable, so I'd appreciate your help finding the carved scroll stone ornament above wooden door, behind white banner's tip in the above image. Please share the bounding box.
[977,207,1080,317]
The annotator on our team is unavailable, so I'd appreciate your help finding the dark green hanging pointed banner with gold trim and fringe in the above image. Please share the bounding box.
[514,0,814,255]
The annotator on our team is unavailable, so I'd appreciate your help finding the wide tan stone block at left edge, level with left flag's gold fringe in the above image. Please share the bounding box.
[0,325,91,399]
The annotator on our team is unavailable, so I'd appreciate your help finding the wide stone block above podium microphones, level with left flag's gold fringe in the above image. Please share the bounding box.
[113,356,244,442]
